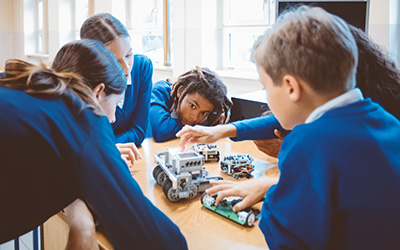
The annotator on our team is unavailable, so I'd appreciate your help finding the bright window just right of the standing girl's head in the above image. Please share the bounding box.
[123,0,172,66]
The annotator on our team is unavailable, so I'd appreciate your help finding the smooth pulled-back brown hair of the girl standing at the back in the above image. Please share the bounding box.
[80,13,130,45]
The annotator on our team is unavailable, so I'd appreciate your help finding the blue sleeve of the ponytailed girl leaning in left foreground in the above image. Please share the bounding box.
[75,118,187,249]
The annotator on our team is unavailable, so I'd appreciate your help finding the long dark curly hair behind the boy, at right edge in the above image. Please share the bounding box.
[349,25,400,119]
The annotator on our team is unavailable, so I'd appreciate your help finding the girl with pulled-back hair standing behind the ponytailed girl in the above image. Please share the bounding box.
[80,13,153,146]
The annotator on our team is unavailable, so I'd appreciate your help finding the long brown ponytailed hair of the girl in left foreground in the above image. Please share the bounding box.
[0,40,126,115]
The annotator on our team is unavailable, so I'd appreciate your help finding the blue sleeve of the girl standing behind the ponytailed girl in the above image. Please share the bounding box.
[115,57,153,146]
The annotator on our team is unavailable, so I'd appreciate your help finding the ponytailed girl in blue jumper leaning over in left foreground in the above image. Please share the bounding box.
[0,40,187,249]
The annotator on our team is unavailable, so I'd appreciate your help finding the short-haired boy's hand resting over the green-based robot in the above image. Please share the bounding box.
[206,176,278,212]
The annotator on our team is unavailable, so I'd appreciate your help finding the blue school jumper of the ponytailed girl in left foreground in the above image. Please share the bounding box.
[0,87,187,249]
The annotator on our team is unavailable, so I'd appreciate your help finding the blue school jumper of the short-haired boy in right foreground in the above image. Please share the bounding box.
[259,99,400,249]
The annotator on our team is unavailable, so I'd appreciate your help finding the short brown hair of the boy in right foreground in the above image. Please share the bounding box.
[252,6,358,93]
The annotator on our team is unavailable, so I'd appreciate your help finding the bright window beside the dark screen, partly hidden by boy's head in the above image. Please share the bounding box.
[222,0,275,70]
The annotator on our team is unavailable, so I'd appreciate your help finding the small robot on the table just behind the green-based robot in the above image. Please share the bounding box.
[220,155,254,180]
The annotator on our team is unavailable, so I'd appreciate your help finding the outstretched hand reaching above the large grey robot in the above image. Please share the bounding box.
[176,124,237,150]
